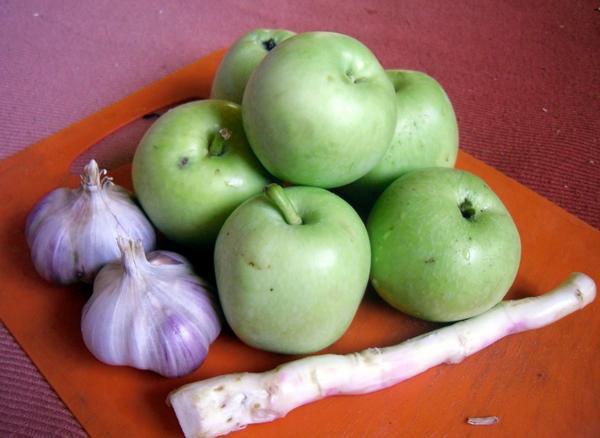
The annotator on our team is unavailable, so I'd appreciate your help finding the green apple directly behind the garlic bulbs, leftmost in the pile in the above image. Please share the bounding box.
[132,100,268,246]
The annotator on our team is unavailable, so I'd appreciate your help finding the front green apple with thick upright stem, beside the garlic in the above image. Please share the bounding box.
[215,184,371,354]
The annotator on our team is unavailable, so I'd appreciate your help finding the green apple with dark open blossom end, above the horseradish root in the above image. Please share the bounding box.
[367,168,521,322]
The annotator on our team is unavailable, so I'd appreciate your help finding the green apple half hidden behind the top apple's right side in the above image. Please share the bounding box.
[340,70,458,210]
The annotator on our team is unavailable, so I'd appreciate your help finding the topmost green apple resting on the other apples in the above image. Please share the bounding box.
[242,32,397,188]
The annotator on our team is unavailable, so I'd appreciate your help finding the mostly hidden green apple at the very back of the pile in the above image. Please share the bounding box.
[210,29,295,103]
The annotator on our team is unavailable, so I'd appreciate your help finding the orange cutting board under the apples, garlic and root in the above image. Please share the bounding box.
[0,51,600,437]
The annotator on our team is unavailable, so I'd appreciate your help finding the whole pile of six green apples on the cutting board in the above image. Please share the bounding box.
[133,29,521,354]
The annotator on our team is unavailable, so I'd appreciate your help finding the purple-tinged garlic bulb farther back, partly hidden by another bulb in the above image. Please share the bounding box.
[25,160,156,284]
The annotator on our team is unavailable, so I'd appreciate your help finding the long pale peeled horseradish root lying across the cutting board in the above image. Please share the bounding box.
[169,273,596,437]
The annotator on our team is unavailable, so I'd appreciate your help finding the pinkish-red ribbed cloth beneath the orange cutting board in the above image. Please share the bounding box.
[0,0,600,436]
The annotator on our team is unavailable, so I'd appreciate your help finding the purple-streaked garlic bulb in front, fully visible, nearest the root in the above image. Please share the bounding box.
[81,238,221,377]
